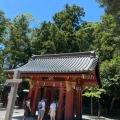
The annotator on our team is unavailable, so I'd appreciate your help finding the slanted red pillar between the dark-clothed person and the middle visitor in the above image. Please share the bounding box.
[31,87,40,115]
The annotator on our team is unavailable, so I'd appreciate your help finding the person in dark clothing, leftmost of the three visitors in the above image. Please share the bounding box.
[23,98,31,120]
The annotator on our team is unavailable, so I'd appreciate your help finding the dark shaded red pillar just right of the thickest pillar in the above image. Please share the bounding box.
[76,89,82,120]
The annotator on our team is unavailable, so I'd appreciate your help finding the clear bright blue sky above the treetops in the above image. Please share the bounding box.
[0,0,104,22]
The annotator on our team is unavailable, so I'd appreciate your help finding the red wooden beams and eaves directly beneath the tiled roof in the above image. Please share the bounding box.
[10,73,98,87]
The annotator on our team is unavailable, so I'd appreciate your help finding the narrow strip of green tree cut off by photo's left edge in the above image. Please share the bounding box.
[0,10,9,99]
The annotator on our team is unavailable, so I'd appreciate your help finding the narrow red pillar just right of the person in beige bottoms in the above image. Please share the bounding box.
[57,88,64,120]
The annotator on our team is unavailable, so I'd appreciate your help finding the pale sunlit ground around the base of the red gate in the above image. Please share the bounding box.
[0,109,119,120]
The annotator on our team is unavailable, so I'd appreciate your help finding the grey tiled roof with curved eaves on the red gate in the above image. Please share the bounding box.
[8,51,98,73]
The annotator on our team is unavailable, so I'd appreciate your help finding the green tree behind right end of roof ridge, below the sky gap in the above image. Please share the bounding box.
[76,21,98,51]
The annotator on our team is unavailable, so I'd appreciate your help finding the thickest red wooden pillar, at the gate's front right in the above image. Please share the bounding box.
[64,88,73,120]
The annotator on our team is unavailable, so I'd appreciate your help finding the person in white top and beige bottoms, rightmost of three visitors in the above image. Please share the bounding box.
[49,101,56,120]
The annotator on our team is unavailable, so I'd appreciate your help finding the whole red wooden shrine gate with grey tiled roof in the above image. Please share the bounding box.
[8,51,101,120]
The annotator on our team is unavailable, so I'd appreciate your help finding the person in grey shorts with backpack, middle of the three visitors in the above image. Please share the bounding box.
[38,99,46,120]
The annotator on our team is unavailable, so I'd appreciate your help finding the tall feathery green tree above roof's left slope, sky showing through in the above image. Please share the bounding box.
[4,14,31,69]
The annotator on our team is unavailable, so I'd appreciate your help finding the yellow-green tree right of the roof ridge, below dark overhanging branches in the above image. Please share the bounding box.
[93,15,117,61]
